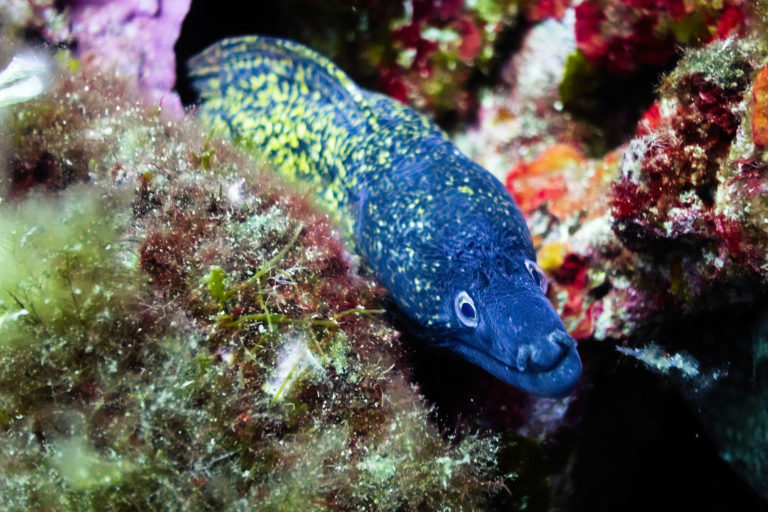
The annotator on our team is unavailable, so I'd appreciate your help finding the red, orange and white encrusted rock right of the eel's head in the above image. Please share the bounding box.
[459,2,765,339]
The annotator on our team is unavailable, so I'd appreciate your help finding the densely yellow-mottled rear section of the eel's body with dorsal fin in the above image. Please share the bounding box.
[189,36,378,216]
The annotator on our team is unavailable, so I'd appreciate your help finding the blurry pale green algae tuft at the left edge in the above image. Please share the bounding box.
[0,188,136,424]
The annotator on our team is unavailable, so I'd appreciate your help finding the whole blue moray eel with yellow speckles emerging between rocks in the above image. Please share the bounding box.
[188,36,581,397]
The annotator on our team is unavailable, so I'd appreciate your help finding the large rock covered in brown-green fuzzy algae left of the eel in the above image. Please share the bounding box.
[0,47,501,511]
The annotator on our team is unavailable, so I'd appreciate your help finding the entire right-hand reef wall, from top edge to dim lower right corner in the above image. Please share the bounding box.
[459,2,768,502]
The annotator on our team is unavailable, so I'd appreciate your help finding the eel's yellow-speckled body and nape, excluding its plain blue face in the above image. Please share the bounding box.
[190,36,533,326]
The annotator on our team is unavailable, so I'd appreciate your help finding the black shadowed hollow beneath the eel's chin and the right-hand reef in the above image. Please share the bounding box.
[401,294,768,512]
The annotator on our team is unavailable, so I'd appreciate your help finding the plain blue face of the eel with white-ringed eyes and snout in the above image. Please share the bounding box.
[440,256,581,397]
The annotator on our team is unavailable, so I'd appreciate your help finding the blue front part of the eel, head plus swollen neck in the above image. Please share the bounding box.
[352,131,581,397]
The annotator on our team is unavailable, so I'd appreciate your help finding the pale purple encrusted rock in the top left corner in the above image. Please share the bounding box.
[0,0,191,117]
